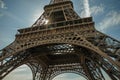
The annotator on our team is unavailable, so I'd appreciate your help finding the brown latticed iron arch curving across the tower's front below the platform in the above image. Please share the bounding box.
[13,32,120,69]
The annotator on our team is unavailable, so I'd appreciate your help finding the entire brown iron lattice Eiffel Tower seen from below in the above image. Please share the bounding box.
[0,0,120,80]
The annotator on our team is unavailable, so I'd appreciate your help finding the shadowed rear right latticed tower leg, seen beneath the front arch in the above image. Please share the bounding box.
[81,54,105,80]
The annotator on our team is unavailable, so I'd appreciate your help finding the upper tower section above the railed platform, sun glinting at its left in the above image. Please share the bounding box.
[32,0,80,27]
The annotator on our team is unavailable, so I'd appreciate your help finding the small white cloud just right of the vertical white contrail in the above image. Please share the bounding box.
[90,4,104,16]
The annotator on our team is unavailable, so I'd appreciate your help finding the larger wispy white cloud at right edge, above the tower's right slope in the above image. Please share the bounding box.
[97,11,120,31]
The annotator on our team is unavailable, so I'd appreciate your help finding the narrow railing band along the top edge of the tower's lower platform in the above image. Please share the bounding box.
[18,17,92,34]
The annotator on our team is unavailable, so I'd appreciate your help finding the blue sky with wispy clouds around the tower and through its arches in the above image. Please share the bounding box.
[0,0,120,80]
